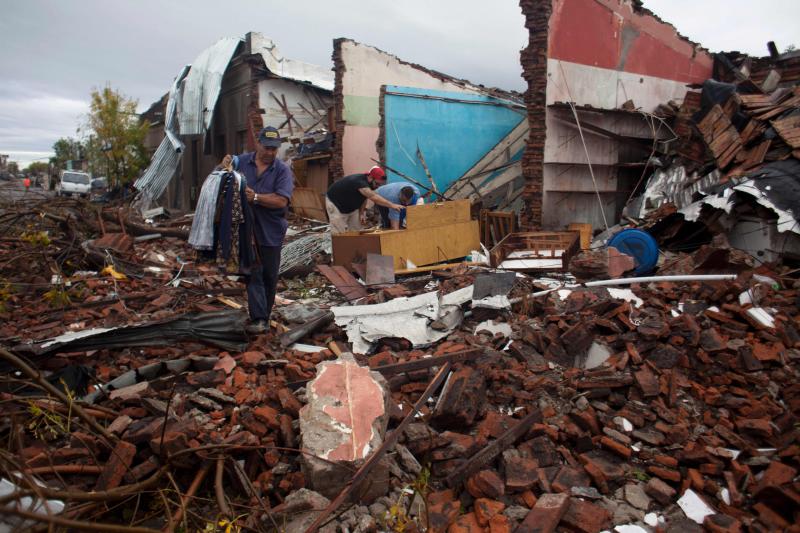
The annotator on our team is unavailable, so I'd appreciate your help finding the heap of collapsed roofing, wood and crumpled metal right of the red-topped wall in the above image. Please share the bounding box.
[631,66,800,262]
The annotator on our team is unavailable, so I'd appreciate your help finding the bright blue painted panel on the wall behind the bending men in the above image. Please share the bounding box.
[383,85,526,192]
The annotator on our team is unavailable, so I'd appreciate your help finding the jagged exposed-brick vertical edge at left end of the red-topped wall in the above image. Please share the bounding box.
[519,0,553,229]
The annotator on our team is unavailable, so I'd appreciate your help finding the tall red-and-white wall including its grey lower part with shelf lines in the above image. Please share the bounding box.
[520,0,713,228]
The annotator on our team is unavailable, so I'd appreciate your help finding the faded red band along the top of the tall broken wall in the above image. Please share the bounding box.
[548,0,713,83]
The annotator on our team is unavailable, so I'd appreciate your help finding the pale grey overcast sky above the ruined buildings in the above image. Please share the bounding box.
[0,0,800,166]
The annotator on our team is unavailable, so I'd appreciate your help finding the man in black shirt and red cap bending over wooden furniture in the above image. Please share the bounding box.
[325,167,403,235]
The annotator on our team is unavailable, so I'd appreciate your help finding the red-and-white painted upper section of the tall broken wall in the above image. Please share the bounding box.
[547,0,713,111]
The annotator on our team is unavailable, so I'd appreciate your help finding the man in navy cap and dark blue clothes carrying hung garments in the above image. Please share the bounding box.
[222,126,294,333]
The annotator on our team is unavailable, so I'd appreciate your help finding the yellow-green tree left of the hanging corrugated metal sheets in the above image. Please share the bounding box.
[86,86,150,184]
